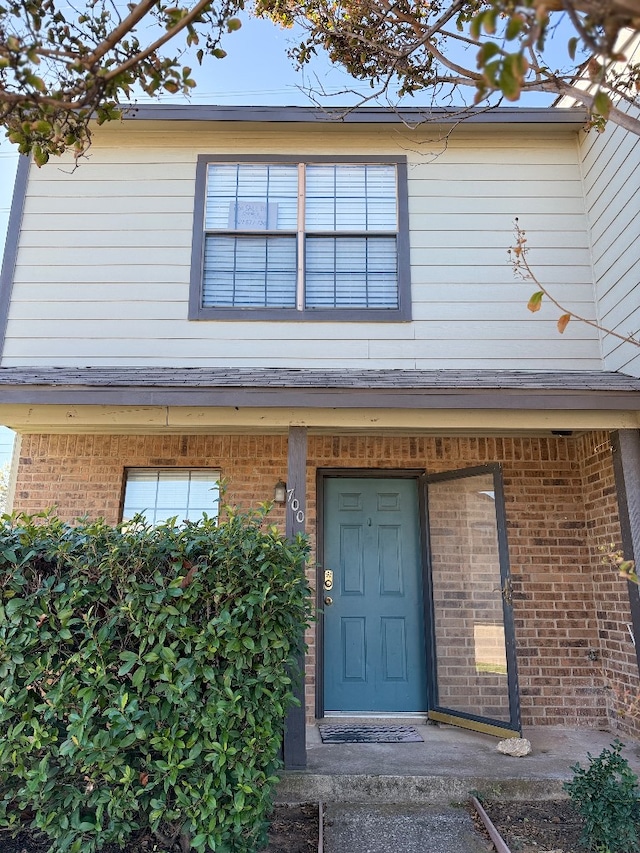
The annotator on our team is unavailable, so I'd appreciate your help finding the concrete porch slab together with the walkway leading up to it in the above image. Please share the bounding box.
[276,720,640,853]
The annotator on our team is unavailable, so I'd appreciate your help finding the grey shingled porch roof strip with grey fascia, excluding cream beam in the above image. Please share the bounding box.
[0,367,640,411]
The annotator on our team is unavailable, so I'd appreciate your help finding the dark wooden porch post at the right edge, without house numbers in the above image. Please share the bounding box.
[611,429,640,669]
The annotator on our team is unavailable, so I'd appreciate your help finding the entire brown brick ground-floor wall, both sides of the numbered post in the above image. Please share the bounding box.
[15,433,637,726]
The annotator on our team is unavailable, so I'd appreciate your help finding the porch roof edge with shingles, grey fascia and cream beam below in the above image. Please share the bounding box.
[0,367,640,432]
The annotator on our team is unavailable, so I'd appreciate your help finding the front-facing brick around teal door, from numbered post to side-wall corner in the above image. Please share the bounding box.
[307,436,607,727]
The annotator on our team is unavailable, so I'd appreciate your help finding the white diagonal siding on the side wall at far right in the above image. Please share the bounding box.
[580,36,640,376]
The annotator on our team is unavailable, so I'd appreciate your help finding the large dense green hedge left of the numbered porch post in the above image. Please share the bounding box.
[0,510,310,853]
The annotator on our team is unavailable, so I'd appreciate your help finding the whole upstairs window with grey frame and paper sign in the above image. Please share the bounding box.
[190,156,410,321]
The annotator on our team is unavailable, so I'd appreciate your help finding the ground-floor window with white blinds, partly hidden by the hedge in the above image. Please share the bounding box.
[122,469,220,524]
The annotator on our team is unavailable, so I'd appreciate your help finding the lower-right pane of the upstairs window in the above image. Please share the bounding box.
[305,237,398,308]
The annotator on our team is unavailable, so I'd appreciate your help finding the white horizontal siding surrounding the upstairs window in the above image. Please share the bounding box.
[2,122,602,370]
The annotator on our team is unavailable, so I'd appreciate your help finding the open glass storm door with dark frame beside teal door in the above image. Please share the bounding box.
[428,467,520,735]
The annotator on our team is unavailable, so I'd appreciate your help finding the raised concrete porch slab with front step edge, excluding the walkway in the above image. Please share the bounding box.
[277,718,640,805]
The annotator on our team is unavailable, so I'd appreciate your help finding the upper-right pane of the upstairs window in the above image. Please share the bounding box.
[305,164,397,231]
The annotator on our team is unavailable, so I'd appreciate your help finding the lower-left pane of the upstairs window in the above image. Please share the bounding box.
[202,235,297,308]
